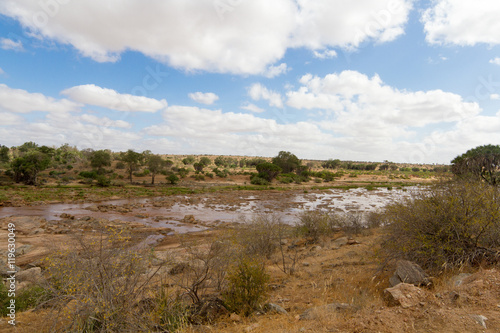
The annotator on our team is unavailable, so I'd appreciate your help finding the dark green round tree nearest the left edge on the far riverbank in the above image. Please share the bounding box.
[11,150,51,185]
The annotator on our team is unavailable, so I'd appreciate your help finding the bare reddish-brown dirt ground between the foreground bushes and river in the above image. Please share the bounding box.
[0,182,500,333]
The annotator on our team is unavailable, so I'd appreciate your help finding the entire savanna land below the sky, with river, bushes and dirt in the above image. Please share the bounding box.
[0,142,500,332]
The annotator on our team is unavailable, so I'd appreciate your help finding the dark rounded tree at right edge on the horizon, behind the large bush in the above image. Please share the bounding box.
[451,145,500,185]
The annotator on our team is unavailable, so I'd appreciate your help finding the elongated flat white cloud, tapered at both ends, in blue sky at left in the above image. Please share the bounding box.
[61,84,167,112]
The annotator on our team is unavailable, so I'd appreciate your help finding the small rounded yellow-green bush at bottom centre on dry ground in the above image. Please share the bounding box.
[223,258,269,315]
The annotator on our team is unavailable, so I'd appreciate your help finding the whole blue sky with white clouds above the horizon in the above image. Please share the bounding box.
[0,0,500,164]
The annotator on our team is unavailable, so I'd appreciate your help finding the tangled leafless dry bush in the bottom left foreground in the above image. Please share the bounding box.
[39,227,173,332]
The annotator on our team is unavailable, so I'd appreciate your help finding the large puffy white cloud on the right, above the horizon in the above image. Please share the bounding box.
[287,71,480,138]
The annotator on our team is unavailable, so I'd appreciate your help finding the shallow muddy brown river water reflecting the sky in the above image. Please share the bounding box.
[0,187,420,233]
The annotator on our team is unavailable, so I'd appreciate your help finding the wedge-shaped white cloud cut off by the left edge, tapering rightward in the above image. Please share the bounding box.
[0,84,81,113]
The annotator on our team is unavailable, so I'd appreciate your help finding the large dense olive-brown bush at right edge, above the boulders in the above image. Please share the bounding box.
[383,181,500,270]
